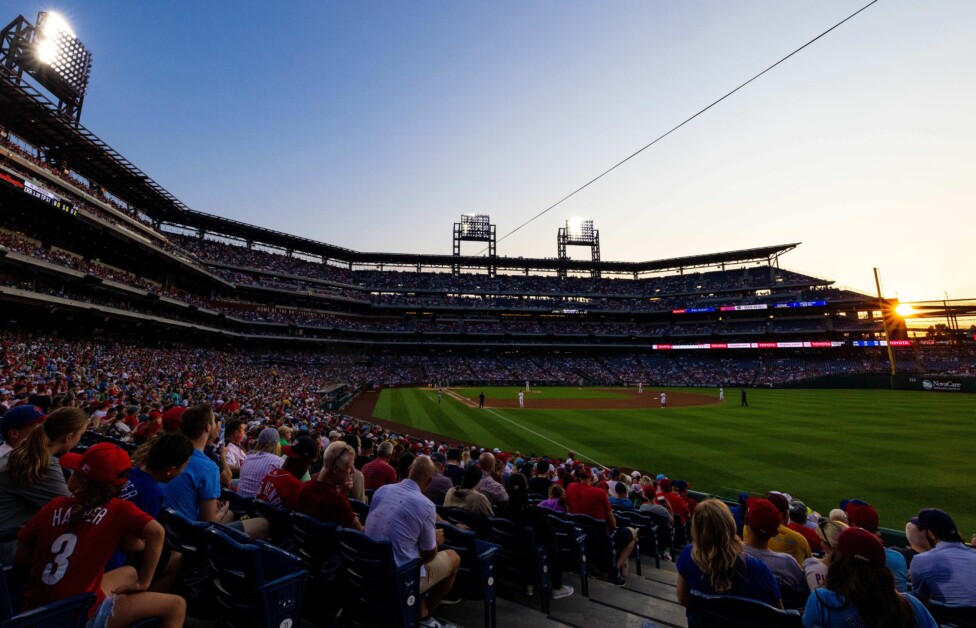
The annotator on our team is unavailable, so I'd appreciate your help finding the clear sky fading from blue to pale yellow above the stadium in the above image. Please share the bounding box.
[9,0,976,300]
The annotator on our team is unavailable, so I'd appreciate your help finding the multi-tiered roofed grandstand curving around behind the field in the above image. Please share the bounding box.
[0,12,976,625]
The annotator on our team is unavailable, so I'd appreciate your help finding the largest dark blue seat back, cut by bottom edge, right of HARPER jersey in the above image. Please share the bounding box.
[205,528,308,628]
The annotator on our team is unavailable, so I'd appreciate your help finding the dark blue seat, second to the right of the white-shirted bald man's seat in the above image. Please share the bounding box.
[491,518,552,615]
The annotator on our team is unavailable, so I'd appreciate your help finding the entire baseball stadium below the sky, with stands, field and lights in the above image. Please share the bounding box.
[0,4,976,627]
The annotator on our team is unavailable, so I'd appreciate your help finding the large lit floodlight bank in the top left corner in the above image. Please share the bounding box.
[0,11,92,121]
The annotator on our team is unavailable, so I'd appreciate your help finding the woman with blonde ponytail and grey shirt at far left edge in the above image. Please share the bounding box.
[0,408,88,565]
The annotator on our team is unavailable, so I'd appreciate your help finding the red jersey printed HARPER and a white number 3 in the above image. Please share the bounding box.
[17,497,153,617]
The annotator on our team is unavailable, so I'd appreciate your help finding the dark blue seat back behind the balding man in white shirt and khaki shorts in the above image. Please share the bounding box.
[338,529,421,628]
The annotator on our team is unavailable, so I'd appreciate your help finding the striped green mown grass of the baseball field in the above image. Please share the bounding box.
[375,387,976,539]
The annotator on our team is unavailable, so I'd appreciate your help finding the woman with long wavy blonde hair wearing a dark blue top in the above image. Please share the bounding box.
[676,499,783,608]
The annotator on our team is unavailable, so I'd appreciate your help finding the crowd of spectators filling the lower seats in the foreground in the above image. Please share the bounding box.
[0,334,976,626]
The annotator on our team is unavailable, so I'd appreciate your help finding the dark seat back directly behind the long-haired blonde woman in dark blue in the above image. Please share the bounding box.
[688,591,803,628]
